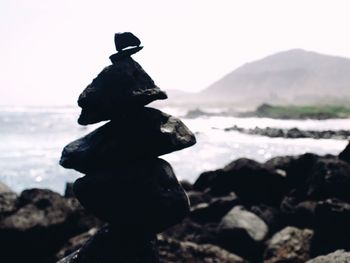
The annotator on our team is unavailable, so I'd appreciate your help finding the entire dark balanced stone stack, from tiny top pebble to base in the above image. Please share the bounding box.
[60,32,196,263]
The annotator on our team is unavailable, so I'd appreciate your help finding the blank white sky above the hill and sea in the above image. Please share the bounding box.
[0,0,350,105]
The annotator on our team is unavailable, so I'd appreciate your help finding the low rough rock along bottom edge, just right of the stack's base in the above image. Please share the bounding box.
[158,236,247,263]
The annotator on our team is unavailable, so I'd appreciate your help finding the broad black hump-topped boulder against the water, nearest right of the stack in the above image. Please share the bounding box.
[194,158,286,205]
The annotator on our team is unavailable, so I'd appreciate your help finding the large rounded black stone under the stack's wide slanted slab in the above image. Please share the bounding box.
[74,159,189,233]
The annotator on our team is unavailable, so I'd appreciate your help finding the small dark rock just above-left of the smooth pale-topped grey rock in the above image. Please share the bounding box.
[190,193,239,223]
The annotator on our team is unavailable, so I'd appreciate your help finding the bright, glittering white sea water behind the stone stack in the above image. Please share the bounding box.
[0,107,350,193]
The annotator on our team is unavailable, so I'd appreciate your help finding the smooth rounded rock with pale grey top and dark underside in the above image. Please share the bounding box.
[218,206,269,261]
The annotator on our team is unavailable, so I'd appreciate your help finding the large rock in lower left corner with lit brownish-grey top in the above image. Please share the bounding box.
[0,189,77,262]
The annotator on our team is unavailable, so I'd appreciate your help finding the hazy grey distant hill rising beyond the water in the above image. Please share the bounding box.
[180,49,350,106]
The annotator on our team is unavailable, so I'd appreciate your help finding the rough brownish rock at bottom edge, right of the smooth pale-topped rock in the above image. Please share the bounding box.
[264,227,313,263]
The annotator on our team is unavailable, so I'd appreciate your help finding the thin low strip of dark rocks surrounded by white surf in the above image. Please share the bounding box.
[224,125,350,140]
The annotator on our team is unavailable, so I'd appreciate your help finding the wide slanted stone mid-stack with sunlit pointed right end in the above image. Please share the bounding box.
[60,108,196,173]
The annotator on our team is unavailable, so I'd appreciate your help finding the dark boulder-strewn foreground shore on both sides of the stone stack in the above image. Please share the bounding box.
[0,144,350,263]
